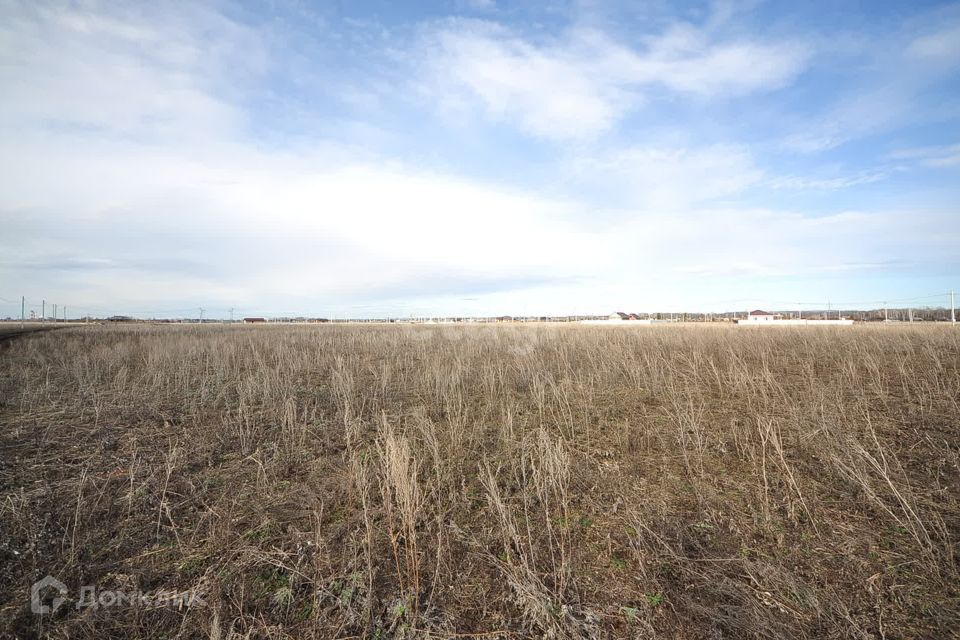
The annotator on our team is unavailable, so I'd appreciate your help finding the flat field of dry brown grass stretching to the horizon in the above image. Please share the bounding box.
[0,325,960,639]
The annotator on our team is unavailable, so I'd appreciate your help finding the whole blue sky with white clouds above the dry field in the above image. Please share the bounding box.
[0,0,960,317]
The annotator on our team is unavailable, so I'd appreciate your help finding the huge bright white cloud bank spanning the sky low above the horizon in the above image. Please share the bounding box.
[0,101,948,313]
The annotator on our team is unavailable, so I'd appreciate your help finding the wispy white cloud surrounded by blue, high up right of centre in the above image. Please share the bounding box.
[423,20,808,140]
